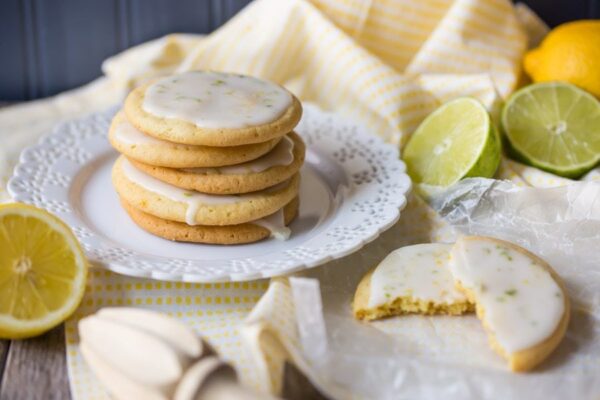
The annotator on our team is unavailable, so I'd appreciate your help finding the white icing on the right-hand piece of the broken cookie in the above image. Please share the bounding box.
[450,238,565,354]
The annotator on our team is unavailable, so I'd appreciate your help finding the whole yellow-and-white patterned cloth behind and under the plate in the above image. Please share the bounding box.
[0,0,560,399]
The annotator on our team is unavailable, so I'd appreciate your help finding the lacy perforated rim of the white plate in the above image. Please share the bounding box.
[7,103,412,283]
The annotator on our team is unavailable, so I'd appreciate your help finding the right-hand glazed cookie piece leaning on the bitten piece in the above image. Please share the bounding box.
[450,236,569,371]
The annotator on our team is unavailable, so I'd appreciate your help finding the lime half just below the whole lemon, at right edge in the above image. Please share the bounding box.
[502,82,600,178]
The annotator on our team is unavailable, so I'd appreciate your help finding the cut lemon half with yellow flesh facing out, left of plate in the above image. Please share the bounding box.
[0,203,87,339]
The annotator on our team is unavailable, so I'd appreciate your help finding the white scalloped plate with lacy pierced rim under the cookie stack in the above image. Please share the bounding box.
[8,105,411,282]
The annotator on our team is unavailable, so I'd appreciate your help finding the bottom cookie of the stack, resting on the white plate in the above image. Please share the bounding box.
[121,197,299,244]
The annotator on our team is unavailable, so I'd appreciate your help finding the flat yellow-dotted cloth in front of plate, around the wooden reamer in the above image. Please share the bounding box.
[65,267,269,400]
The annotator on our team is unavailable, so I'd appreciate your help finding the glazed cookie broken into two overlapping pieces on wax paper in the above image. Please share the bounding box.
[352,236,570,371]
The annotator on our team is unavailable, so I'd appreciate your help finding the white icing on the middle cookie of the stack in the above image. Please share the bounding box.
[183,136,294,175]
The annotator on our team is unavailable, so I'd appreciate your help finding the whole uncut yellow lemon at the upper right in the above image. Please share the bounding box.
[524,20,600,97]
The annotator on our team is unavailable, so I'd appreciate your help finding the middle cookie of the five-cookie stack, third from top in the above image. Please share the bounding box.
[130,133,304,194]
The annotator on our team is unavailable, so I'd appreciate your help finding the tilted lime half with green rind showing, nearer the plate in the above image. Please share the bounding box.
[403,97,501,186]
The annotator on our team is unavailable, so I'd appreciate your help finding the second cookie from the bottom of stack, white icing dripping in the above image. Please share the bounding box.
[112,156,300,225]
